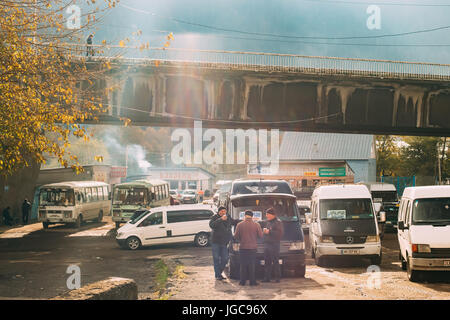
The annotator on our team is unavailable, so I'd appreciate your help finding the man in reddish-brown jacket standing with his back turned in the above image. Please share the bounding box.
[234,210,263,286]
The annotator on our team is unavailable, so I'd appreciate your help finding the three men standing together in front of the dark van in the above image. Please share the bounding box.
[209,207,283,286]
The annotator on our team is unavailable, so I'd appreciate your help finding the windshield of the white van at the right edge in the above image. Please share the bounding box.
[412,198,450,224]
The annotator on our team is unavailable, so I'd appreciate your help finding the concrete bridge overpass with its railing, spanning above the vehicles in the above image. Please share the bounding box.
[72,46,450,136]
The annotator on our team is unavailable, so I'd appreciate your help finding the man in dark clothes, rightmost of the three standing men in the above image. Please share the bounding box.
[263,208,284,282]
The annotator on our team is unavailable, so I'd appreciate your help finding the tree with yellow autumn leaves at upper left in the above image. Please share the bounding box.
[0,0,121,176]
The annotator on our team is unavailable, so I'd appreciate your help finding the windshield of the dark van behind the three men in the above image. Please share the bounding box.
[232,196,300,221]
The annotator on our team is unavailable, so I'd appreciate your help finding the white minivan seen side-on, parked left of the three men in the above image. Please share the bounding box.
[116,204,214,250]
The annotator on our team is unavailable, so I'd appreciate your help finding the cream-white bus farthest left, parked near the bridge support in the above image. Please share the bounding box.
[38,181,111,229]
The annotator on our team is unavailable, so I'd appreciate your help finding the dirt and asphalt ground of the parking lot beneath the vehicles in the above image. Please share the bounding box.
[0,217,450,300]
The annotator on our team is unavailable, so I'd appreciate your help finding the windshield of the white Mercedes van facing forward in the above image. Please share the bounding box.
[320,199,374,220]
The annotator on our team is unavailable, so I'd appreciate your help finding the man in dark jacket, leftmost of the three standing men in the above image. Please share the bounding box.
[209,207,232,280]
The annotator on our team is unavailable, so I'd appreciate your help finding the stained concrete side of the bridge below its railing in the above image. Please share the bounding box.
[89,64,450,136]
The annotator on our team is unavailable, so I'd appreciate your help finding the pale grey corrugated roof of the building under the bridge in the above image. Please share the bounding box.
[280,132,375,161]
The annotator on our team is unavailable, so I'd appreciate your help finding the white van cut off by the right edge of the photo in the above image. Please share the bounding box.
[397,186,450,281]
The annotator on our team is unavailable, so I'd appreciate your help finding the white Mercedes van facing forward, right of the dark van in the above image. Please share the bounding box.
[309,185,385,265]
